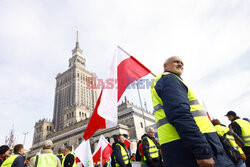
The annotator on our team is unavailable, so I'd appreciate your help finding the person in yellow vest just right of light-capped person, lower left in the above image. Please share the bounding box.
[62,146,77,167]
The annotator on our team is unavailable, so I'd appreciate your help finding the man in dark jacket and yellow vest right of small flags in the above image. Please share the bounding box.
[113,134,131,167]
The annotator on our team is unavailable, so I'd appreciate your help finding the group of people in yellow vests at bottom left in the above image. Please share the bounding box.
[0,140,77,167]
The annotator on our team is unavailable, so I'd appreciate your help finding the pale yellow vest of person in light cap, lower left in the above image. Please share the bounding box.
[35,153,57,167]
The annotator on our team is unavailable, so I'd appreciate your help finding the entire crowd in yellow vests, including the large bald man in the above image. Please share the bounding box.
[0,56,250,167]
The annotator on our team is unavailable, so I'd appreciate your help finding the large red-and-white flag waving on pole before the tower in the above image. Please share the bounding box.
[83,46,150,140]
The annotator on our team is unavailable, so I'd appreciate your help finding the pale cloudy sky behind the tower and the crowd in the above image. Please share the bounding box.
[0,0,250,149]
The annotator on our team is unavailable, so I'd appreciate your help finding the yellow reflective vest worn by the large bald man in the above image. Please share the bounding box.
[150,72,215,145]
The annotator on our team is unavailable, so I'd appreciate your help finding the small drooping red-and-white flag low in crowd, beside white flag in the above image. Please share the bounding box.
[93,135,113,165]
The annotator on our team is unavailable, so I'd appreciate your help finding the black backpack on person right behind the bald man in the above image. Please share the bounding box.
[220,133,242,164]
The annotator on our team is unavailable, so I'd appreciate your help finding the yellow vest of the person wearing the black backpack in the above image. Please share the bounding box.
[215,125,243,154]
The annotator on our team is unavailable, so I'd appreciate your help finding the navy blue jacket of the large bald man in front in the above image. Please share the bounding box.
[155,72,233,167]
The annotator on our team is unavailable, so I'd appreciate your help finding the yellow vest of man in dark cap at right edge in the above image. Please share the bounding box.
[233,119,250,146]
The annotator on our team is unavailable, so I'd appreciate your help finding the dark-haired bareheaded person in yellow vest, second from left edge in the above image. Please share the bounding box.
[1,144,25,167]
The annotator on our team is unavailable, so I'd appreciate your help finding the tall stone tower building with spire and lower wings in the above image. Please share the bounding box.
[29,34,155,155]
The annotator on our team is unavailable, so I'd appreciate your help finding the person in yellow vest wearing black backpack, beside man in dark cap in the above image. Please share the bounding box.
[212,119,246,167]
